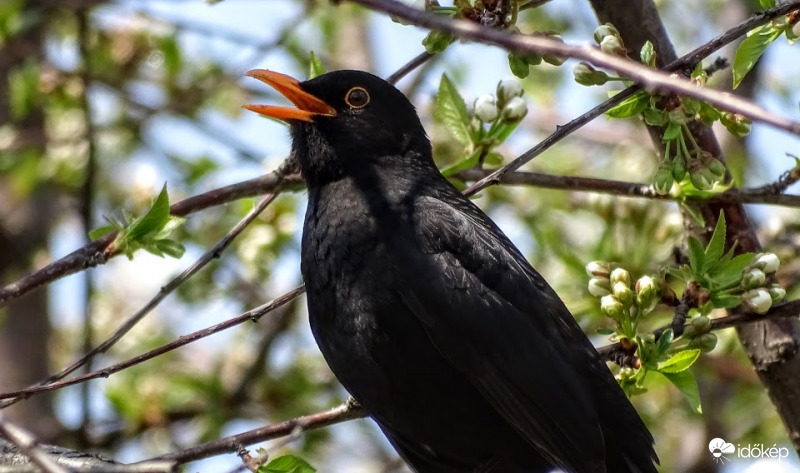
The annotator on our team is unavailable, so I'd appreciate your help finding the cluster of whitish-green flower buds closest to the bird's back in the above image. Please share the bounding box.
[586,261,661,323]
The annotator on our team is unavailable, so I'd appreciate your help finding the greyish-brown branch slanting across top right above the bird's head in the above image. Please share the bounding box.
[350,0,800,135]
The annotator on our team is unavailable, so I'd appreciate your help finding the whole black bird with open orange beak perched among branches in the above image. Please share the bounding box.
[246,69,658,473]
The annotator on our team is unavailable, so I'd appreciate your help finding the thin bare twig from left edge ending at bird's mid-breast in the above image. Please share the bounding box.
[0,286,305,399]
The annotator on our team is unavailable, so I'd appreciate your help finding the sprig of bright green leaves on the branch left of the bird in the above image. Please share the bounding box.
[89,184,186,259]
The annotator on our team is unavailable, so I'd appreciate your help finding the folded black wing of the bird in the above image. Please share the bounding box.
[397,191,607,472]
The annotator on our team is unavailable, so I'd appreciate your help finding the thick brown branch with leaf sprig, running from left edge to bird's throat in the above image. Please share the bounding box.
[0,166,302,307]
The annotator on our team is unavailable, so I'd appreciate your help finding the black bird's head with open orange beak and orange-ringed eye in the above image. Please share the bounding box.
[245,69,432,185]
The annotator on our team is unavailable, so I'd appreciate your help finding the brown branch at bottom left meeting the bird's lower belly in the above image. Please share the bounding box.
[147,398,367,464]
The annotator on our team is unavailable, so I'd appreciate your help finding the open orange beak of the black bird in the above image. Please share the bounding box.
[244,69,336,122]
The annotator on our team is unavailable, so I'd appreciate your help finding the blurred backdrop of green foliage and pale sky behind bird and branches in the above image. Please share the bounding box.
[0,0,800,473]
